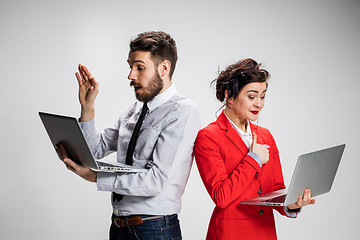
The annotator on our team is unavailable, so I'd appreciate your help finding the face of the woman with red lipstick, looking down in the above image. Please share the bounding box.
[227,82,267,121]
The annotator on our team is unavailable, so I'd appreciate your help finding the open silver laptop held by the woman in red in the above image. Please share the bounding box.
[241,144,345,206]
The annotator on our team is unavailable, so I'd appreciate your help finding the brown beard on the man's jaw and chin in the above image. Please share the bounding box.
[130,71,164,102]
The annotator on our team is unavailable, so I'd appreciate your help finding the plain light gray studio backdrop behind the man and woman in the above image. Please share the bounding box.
[0,0,360,240]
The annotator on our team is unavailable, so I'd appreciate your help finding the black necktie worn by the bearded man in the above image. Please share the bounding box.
[113,103,149,202]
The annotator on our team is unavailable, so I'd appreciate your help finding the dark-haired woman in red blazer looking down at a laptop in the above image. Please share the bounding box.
[195,59,315,240]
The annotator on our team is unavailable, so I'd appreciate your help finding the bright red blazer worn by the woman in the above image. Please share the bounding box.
[195,112,292,240]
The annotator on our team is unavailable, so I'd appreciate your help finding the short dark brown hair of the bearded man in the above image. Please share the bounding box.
[129,31,178,78]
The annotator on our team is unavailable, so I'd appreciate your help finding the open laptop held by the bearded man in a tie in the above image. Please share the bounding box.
[39,112,147,172]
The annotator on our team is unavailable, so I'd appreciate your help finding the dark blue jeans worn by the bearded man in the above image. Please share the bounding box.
[110,214,182,240]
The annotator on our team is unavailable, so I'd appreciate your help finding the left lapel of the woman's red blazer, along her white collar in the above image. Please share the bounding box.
[217,111,249,155]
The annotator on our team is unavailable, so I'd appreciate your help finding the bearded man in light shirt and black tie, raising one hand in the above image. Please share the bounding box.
[58,32,200,239]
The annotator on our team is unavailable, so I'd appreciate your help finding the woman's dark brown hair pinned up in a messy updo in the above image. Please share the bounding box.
[212,58,270,102]
